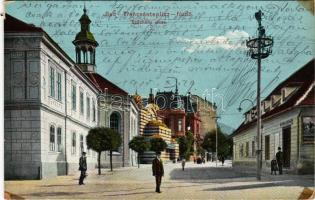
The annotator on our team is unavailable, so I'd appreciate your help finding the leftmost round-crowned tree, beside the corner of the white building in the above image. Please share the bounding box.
[86,127,106,175]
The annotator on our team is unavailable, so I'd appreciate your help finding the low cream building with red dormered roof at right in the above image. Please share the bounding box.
[232,60,315,173]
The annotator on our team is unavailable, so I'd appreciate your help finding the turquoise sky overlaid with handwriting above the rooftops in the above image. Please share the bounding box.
[6,1,315,128]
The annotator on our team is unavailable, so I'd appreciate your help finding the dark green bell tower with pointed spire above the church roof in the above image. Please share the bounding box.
[72,5,98,72]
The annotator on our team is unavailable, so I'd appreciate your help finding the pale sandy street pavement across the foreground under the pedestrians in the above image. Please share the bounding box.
[5,161,314,199]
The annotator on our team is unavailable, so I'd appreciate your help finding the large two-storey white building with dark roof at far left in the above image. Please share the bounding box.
[4,15,99,179]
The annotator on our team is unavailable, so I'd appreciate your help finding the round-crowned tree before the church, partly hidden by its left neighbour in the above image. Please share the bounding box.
[104,128,122,171]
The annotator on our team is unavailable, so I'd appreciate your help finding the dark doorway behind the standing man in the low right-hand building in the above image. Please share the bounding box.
[282,126,291,168]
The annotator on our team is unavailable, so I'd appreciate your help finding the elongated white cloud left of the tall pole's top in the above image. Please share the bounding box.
[176,30,249,53]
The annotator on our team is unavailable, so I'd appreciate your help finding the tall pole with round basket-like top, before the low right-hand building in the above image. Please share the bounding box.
[246,10,273,180]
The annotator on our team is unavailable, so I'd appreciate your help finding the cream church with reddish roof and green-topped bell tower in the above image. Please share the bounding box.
[72,8,139,167]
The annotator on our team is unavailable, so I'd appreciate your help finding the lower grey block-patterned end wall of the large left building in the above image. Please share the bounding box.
[4,110,41,179]
